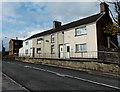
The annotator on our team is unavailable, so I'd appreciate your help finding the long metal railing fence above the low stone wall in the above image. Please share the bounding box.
[19,51,120,62]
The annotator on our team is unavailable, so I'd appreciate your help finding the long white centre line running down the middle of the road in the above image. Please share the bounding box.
[24,66,120,90]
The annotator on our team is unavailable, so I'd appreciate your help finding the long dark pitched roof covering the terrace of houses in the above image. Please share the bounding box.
[26,13,103,40]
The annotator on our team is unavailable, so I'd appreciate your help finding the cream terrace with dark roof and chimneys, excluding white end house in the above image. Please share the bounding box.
[20,3,117,58]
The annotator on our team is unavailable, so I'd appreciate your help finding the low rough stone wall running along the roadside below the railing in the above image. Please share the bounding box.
[16,58,120,74]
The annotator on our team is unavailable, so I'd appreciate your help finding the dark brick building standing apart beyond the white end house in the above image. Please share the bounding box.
[9,38,23,56]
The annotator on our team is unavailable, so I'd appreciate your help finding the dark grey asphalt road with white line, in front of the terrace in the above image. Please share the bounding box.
[2,61,120,92]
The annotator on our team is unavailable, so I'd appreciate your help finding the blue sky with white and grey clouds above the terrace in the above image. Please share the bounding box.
[0,2,118,51]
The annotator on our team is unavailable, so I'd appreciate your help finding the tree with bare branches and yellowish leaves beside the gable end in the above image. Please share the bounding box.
[103,0,120,36]
